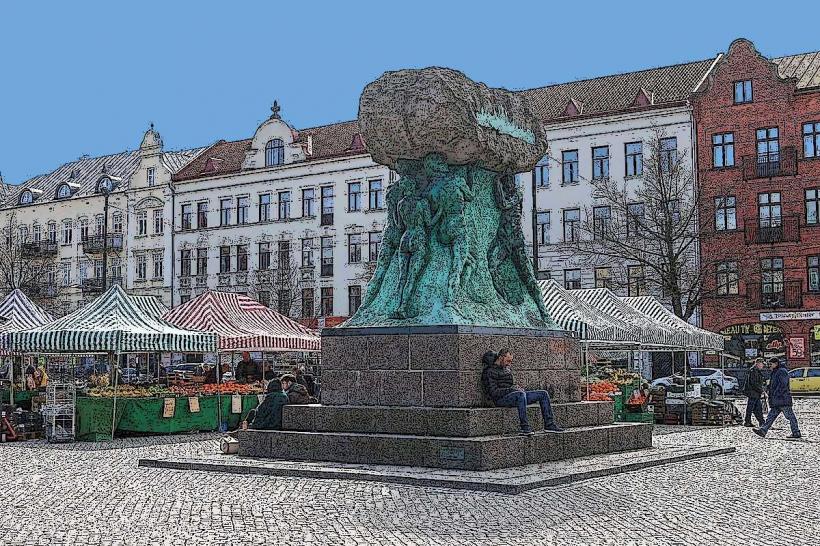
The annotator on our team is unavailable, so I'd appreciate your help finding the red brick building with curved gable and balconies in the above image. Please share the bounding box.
[692,39,820,367]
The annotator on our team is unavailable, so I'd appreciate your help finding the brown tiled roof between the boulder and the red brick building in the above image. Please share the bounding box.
[523,59,714,121]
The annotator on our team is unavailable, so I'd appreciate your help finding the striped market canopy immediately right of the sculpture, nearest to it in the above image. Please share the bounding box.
[538,279,641,347]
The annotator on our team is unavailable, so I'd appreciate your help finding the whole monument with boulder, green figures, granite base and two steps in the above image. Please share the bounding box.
[240,68,651,469]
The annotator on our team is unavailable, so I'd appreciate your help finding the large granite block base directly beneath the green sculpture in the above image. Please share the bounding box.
[322,326,581,408]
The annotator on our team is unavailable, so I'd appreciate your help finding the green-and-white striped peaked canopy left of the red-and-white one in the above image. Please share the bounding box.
[8,285,217,353]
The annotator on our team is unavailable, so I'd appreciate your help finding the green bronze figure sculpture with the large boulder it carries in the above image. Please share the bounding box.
[343,68,556,329]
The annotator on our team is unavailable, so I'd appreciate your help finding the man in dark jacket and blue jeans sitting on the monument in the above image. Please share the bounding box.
[482,349,564,434]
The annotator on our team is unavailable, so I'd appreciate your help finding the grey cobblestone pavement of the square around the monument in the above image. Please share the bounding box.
[0,399,820,546]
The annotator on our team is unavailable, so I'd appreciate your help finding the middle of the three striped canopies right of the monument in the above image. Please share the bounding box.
[569,288,687,349]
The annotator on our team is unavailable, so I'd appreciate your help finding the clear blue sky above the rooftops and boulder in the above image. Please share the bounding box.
[0,0,820,183]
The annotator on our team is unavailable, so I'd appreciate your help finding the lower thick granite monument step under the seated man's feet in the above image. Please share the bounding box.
[238,423,652,470]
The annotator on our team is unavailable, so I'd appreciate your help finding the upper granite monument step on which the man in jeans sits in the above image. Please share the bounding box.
[282,402,613,437]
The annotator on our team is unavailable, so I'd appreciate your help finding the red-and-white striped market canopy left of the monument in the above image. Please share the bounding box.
[163,291,320,352]
